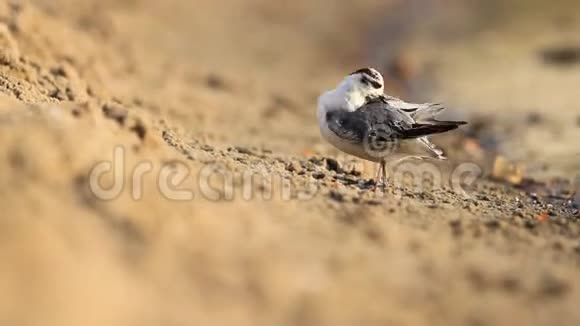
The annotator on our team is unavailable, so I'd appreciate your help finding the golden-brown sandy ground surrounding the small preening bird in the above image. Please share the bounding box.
[0,0,580,325]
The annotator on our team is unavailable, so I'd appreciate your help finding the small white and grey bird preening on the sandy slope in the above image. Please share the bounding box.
[318,68,466,186]
